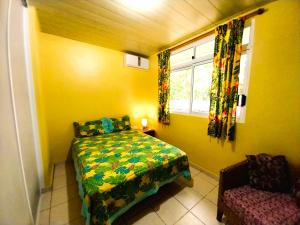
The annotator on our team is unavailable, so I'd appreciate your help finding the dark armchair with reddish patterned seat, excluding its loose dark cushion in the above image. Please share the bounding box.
[217,157,300,225]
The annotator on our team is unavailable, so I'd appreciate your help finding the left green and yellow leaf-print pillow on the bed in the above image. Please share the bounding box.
[73,120,104,137]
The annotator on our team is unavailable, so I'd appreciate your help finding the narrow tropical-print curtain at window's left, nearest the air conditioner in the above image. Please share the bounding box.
[158,49,170,124]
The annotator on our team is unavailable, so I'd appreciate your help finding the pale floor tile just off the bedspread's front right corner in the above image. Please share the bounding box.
[174,187,203,210]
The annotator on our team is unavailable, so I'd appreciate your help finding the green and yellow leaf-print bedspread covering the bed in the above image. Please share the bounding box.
[72,130,191,225]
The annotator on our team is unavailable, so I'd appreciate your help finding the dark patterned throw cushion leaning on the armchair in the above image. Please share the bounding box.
[246,154,290,192]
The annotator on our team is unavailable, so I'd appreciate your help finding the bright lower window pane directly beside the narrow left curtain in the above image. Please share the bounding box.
[170,68,192,112]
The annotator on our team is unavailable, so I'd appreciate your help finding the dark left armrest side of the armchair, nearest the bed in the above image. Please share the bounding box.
[219,160,249,196]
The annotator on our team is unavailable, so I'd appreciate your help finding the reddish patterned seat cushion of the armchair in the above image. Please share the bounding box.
[224,185,300,225]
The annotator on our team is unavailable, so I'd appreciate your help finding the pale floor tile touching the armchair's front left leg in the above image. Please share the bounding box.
[191,199,222,225]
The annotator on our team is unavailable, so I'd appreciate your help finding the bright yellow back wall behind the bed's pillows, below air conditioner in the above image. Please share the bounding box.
[34,30,157,163]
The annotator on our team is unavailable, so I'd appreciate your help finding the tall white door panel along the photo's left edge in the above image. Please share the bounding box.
[0,0,40,225]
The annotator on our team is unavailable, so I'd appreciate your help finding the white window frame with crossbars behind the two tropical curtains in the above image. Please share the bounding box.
[170,19,255,123]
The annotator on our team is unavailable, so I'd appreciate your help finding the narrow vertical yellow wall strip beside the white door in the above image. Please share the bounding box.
[29,7,53,188]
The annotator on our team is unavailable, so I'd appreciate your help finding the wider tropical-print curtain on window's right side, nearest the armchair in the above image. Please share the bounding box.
[208,19,244,141]
